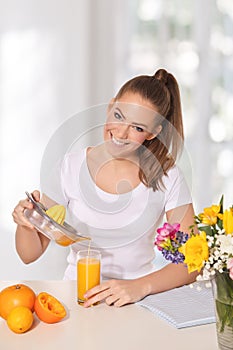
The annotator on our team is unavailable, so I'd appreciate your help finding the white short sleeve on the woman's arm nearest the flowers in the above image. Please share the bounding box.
[163,166,192,212]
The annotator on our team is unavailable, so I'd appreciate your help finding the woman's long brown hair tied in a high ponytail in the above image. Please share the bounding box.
[115,69,184,191]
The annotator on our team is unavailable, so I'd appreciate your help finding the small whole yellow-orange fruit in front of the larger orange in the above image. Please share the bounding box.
[7,306,34,333]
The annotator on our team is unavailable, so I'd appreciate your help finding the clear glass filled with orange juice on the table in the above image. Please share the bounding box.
[77,249,101,305]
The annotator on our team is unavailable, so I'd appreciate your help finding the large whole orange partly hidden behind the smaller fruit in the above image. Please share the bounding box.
[0,284,36,320]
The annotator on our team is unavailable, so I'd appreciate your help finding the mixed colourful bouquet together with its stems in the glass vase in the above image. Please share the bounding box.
[155,196,233,334]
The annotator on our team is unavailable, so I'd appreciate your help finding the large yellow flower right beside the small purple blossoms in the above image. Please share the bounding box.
[179,231,209,273]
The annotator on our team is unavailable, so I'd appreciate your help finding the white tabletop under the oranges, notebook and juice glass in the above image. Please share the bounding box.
[0,281,218,350]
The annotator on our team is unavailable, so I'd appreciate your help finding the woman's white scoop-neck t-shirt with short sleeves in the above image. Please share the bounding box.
[61,149,191,279]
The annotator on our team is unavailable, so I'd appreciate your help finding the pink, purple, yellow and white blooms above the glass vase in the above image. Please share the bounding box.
[155,197,233,280]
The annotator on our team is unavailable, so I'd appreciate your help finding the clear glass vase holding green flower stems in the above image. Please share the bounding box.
[212,272,233,350]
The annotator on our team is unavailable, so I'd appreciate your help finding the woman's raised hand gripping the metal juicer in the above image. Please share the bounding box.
[12,190,40,229]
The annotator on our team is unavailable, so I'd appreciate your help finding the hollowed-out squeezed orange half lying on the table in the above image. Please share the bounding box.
[34,292,66,323]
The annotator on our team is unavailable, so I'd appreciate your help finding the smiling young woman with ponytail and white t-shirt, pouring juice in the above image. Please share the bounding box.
[13,69,196,306]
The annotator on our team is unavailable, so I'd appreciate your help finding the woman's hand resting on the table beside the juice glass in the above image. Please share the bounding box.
[84,279,147,307]
